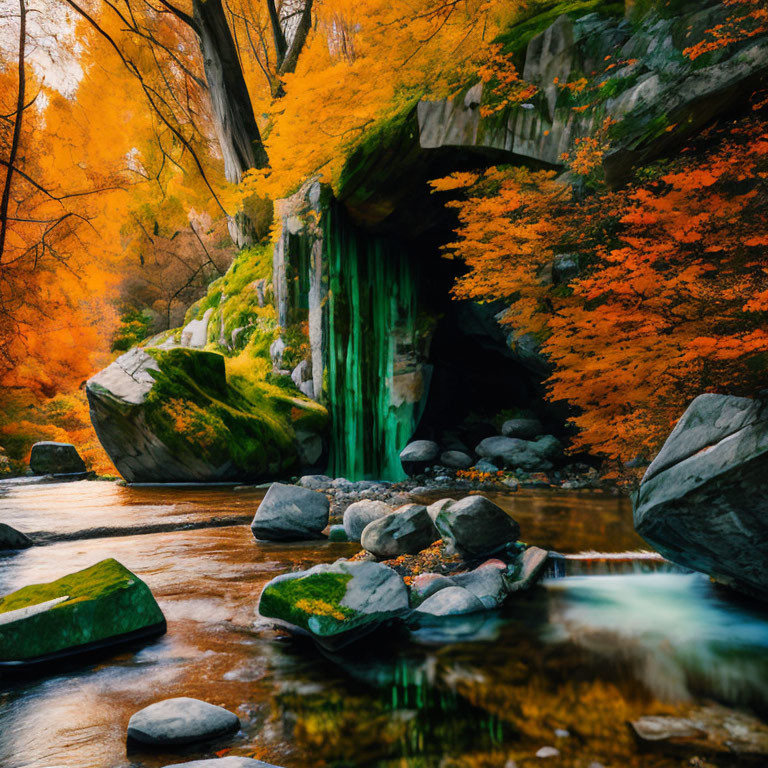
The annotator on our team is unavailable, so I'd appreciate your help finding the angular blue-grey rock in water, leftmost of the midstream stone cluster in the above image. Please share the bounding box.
[251,483,331,541]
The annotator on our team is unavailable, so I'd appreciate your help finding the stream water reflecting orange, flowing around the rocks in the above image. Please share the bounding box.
[0,482,768,768]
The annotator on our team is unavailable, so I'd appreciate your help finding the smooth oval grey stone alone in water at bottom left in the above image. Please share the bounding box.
[128,697,240,746]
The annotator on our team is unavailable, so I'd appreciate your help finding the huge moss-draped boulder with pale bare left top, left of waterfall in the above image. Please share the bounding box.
[86,347,327,482]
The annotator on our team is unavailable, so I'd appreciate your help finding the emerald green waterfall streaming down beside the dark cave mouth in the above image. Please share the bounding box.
[324,206,428,480]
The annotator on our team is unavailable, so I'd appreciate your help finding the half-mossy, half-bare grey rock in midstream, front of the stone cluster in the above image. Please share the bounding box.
[259,560,408,650]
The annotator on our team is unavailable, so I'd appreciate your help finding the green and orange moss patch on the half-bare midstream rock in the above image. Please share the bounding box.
[259,573,357,635]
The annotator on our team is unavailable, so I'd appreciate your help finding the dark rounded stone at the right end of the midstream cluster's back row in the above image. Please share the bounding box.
[435,496,520,557]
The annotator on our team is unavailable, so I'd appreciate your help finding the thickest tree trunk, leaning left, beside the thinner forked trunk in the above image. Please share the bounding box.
[192,0,268,184]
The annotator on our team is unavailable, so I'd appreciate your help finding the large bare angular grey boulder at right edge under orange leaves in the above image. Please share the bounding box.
[633,394,768,599]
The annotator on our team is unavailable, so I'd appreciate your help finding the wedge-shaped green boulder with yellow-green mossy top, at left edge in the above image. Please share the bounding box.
[0,559,166,667]
